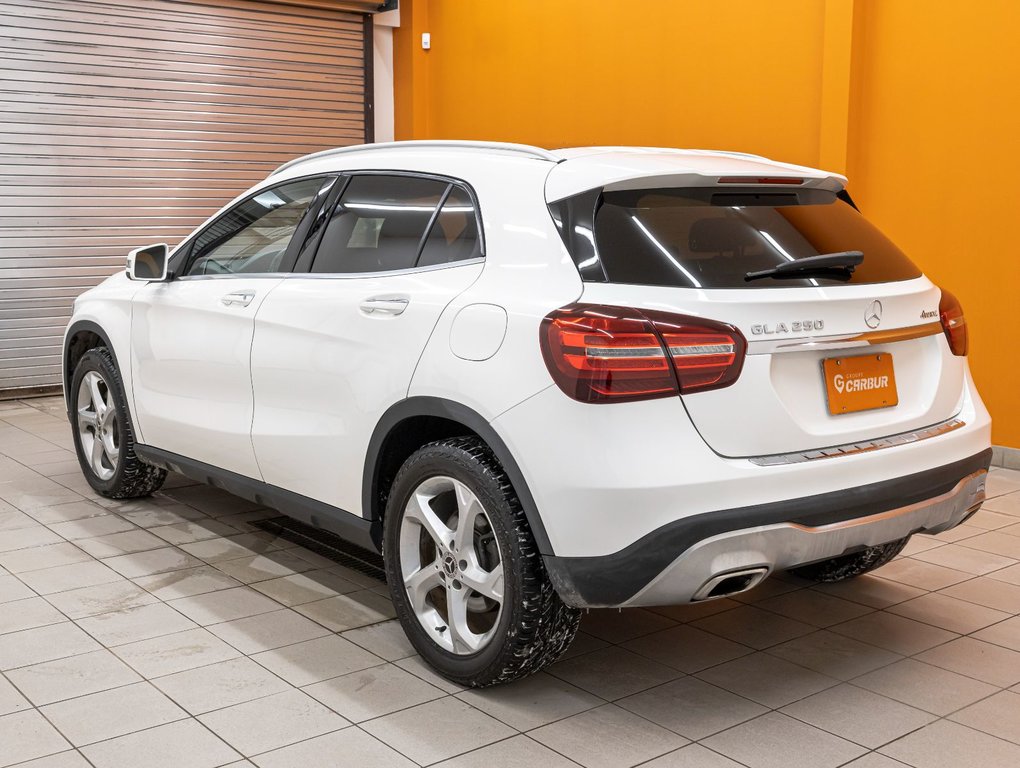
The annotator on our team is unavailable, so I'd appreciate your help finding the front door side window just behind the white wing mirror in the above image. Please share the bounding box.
[185,178,323,274]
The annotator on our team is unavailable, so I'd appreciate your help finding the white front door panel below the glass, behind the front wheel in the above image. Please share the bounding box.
[131,275,284,479]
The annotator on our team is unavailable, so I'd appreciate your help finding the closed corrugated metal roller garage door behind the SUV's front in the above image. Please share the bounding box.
[0,0,371,394]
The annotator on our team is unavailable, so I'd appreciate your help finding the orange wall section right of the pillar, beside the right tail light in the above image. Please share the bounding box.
[849,0,1020,448]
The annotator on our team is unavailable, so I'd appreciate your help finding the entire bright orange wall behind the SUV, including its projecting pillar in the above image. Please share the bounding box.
[394,0,1020,447]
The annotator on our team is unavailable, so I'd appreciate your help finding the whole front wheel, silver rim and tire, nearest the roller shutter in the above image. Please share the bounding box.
[68,347,166,499]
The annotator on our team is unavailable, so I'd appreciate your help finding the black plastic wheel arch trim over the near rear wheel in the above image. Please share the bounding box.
[361,396,555,555]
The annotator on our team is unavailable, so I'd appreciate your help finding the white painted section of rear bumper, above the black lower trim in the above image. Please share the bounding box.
[492,359,991,558]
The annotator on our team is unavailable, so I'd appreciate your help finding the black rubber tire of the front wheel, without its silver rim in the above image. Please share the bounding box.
[67,347,166,499]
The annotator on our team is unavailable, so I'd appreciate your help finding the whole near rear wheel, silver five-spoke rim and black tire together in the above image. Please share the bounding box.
[384,438,580,687]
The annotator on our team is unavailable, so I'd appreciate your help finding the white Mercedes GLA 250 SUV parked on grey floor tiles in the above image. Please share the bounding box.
[63,142,991,685]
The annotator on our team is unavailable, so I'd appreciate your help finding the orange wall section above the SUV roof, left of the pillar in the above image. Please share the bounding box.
[395,0,824,162]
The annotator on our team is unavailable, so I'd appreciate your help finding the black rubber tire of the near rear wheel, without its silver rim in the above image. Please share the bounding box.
[384,437,580,687]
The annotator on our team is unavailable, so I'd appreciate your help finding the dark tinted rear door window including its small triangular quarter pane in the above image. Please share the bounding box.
[311,174,478,274]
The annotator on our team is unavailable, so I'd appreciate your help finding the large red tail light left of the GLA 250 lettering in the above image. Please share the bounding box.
[541,304,747,403]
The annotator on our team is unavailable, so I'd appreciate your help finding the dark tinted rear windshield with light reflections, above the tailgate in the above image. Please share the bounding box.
[550,187,921,289]
